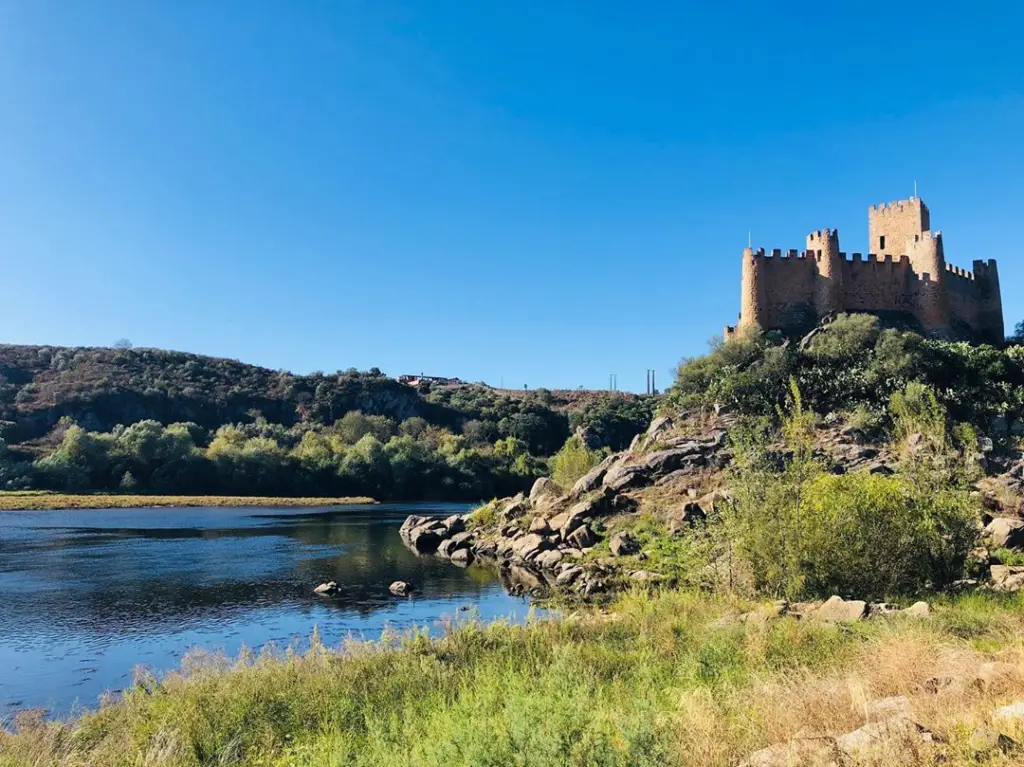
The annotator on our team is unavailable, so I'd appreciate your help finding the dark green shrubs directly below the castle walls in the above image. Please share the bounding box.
[664,314,1024,430]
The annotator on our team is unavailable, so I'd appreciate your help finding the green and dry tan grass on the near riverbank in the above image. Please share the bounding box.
[6,592,1024,767]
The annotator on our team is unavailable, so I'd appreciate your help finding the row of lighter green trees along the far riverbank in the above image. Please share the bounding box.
[0,412,545,501]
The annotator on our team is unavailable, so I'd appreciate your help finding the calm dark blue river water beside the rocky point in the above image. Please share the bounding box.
[0,504,528,720]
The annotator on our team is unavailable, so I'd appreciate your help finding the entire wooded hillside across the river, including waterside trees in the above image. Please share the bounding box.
[0,346,656,500]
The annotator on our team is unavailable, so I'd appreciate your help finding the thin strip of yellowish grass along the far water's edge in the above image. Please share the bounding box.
[0,492,376,511]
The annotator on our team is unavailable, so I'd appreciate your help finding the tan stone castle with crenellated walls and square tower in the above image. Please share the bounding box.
[725,197,1004,343]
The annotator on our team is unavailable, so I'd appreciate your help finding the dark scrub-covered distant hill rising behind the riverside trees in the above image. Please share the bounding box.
[0,345,650,455]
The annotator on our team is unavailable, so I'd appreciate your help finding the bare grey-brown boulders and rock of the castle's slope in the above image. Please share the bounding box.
[401,407,1024,598]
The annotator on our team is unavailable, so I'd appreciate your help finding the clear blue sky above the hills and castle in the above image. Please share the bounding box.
[0,0,1024,390]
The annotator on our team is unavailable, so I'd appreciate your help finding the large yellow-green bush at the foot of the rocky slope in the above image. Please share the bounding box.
[724,380,978,599]
